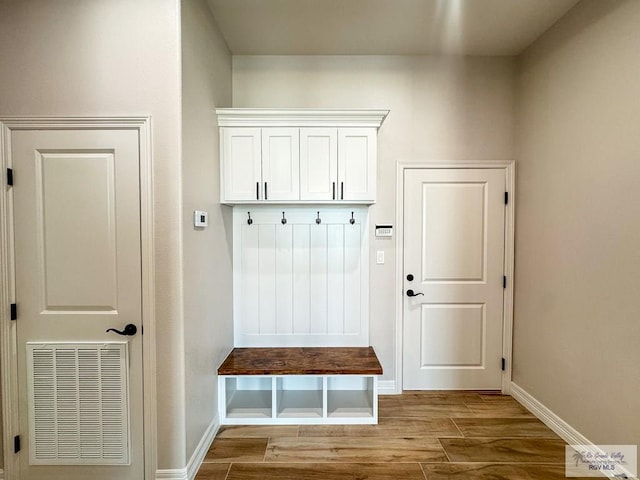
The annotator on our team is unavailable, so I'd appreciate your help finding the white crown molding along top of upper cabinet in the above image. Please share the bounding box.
[216,108,389,128]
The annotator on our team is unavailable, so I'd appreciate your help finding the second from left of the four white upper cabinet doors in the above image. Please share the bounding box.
[262,128,300,201]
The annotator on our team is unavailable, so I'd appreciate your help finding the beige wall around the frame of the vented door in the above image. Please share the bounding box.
[0,0,185,468]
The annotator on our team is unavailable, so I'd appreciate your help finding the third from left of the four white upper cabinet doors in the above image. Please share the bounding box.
[300,128,338,200]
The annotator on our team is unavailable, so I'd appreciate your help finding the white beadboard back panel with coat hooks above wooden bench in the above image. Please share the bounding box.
[233,206,369,347]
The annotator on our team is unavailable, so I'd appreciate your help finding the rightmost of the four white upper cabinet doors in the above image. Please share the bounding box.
[338,128,377,202]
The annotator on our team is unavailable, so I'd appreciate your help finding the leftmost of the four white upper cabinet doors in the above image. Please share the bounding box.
[220,127,262,202]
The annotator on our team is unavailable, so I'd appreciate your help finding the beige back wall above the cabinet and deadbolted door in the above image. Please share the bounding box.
[233,56,515,386]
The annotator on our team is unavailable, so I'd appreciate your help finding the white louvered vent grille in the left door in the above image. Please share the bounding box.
[27,342,129,465]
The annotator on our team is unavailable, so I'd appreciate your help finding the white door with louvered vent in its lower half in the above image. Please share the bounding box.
[10,129,144,480]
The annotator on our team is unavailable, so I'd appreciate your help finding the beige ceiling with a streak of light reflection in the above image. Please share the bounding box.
[208,0,578,55]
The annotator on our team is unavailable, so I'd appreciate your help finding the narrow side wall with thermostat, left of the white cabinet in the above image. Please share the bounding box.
[182,0,233,460]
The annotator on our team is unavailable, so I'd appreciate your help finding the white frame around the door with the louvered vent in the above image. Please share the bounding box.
[0,116,157,480]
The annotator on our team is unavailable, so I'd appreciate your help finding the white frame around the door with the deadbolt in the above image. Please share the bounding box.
[395,160,516,395]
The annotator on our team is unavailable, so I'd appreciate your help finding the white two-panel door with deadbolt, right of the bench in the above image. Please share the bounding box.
[403,169,506,390]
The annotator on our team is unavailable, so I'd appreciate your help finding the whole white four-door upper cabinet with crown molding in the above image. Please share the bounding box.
[216,108,389,204]
